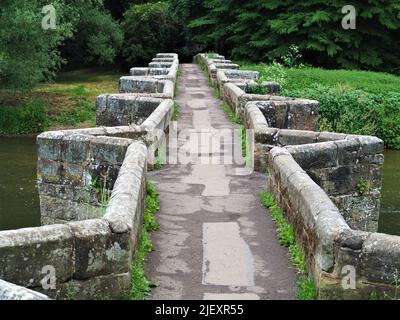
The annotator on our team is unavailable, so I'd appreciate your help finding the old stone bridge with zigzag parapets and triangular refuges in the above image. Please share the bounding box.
[0,54,400,299]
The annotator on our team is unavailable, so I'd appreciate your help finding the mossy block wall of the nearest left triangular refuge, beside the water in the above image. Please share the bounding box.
[37,131,133,224]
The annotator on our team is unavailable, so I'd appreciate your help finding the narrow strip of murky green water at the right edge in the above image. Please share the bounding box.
[379,150,400,235]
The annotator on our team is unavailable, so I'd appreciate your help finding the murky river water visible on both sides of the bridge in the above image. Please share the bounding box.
[0,137,400,235]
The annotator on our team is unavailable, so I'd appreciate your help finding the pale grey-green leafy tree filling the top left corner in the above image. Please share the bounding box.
[0,0,72,89]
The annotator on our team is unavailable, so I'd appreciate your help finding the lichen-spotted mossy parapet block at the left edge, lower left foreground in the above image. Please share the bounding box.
[0,225,74,287]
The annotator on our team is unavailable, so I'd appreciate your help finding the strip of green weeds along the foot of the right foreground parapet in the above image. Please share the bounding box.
[260,192,317,300]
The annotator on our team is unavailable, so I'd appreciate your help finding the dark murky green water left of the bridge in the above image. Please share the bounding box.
[0,138,40,230]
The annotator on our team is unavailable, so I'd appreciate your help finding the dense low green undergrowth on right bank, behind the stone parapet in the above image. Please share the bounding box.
[283,84,400,149]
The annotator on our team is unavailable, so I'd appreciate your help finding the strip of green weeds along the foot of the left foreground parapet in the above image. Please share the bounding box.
[128,181,160,300]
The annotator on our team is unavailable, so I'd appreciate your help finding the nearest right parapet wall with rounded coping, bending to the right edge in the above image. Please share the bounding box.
[268,146,400,299]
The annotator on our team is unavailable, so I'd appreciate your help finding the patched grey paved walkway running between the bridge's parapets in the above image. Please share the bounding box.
[147,64,296,300]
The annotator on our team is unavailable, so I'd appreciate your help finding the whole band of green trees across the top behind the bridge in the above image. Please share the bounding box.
[0,0,400,89]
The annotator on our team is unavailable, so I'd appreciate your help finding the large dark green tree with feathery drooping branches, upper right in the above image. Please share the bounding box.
[190,0,400,72]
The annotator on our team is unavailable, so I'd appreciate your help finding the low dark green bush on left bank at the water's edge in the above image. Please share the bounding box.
[0,99,49,134]
